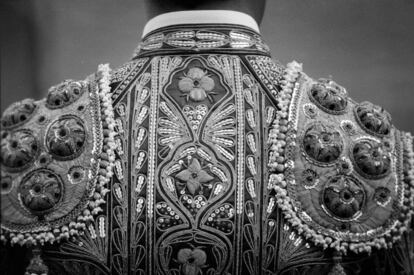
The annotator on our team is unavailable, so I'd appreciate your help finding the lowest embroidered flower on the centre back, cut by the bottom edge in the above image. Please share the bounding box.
[177,248,207,275]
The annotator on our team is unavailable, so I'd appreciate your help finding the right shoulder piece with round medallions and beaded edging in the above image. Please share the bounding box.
[268,62,414,254]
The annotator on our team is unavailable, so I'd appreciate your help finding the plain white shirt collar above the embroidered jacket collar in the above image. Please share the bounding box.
[142,10,260,37]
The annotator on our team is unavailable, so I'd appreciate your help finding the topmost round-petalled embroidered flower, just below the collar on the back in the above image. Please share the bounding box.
[178,67,215,102]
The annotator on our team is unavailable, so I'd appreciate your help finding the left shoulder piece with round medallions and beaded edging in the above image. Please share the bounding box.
[0,65,116,245]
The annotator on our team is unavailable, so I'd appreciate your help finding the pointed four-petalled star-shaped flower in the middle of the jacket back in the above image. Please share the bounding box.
[175,158,214,195]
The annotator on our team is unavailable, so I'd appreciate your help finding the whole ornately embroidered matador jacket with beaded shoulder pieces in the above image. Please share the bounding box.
[1,10,414,275]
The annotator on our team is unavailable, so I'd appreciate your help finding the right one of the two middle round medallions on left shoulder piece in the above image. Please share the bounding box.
[46,116,86,160]
